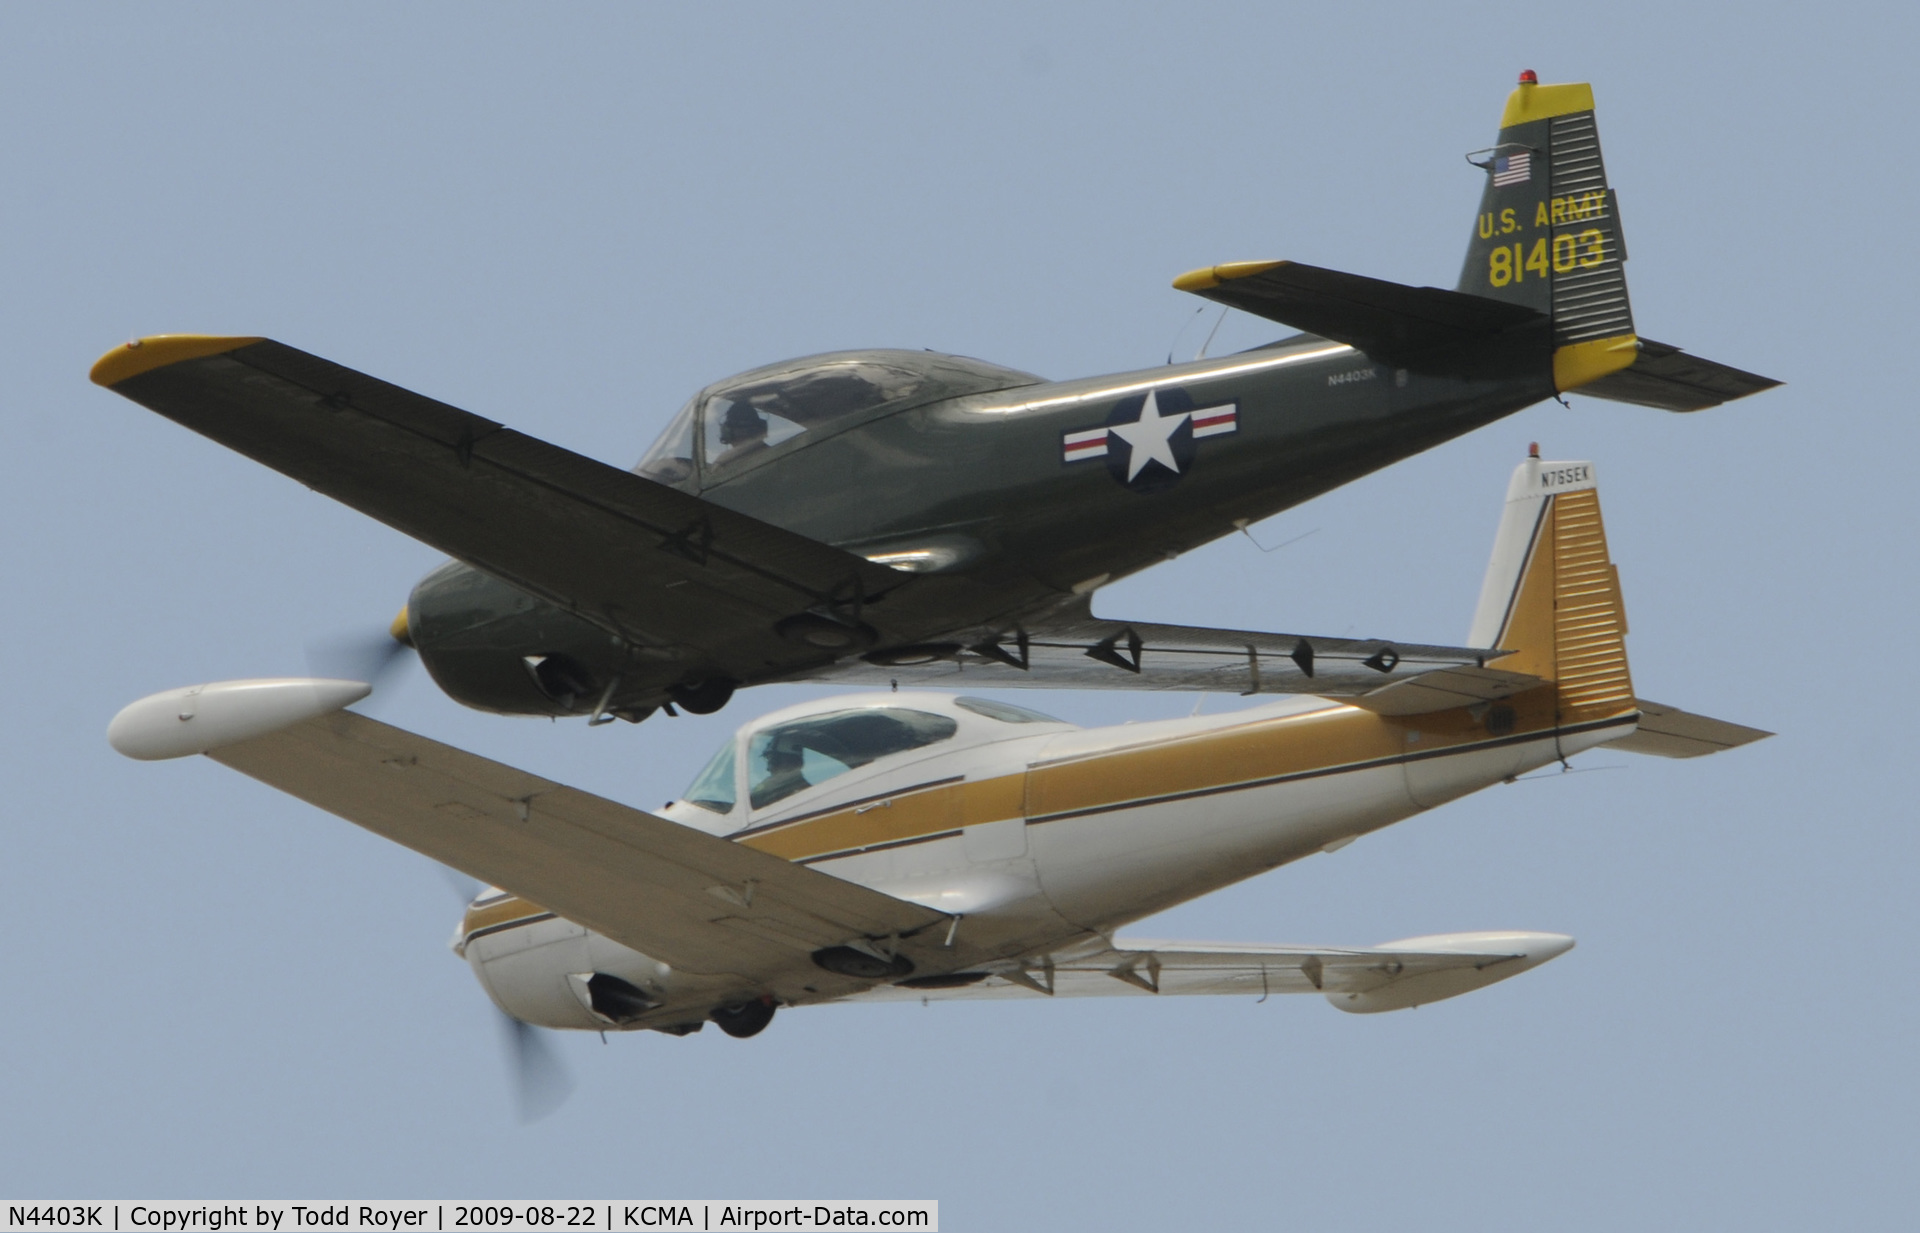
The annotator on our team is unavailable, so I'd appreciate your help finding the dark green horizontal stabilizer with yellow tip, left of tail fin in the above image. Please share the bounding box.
[1173,261,1549,376]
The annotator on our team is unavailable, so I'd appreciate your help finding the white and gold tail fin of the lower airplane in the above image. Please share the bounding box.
[1467,446,1634,722]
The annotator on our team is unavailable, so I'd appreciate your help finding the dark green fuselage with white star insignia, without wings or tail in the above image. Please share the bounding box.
[407,336,1553,714]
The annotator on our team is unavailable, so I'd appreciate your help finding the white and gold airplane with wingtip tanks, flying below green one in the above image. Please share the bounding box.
[109,451,1768,1037]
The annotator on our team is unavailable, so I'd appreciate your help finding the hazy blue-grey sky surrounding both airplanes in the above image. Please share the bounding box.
[0,4,1920,1231]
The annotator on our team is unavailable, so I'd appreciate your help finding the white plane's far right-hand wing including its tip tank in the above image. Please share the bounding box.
[849,924,1572,1012]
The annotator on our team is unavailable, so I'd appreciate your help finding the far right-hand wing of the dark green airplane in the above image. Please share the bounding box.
[789,607,1540,714]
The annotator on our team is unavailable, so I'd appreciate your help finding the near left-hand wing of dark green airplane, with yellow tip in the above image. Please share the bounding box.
[92,336,944,666]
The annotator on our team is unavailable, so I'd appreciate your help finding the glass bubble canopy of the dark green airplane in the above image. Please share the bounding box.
[634,350,1043,484]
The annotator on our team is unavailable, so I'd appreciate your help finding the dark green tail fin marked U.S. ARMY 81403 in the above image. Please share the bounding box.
[1459,71,1640,392]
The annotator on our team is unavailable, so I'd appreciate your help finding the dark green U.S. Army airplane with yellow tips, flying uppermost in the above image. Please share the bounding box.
[92,73,1778,722]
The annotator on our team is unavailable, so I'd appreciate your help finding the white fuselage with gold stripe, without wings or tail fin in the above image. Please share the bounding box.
[455,689,1638,1029]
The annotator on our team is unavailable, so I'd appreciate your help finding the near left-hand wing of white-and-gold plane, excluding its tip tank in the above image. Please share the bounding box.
[207,711,954,979]
